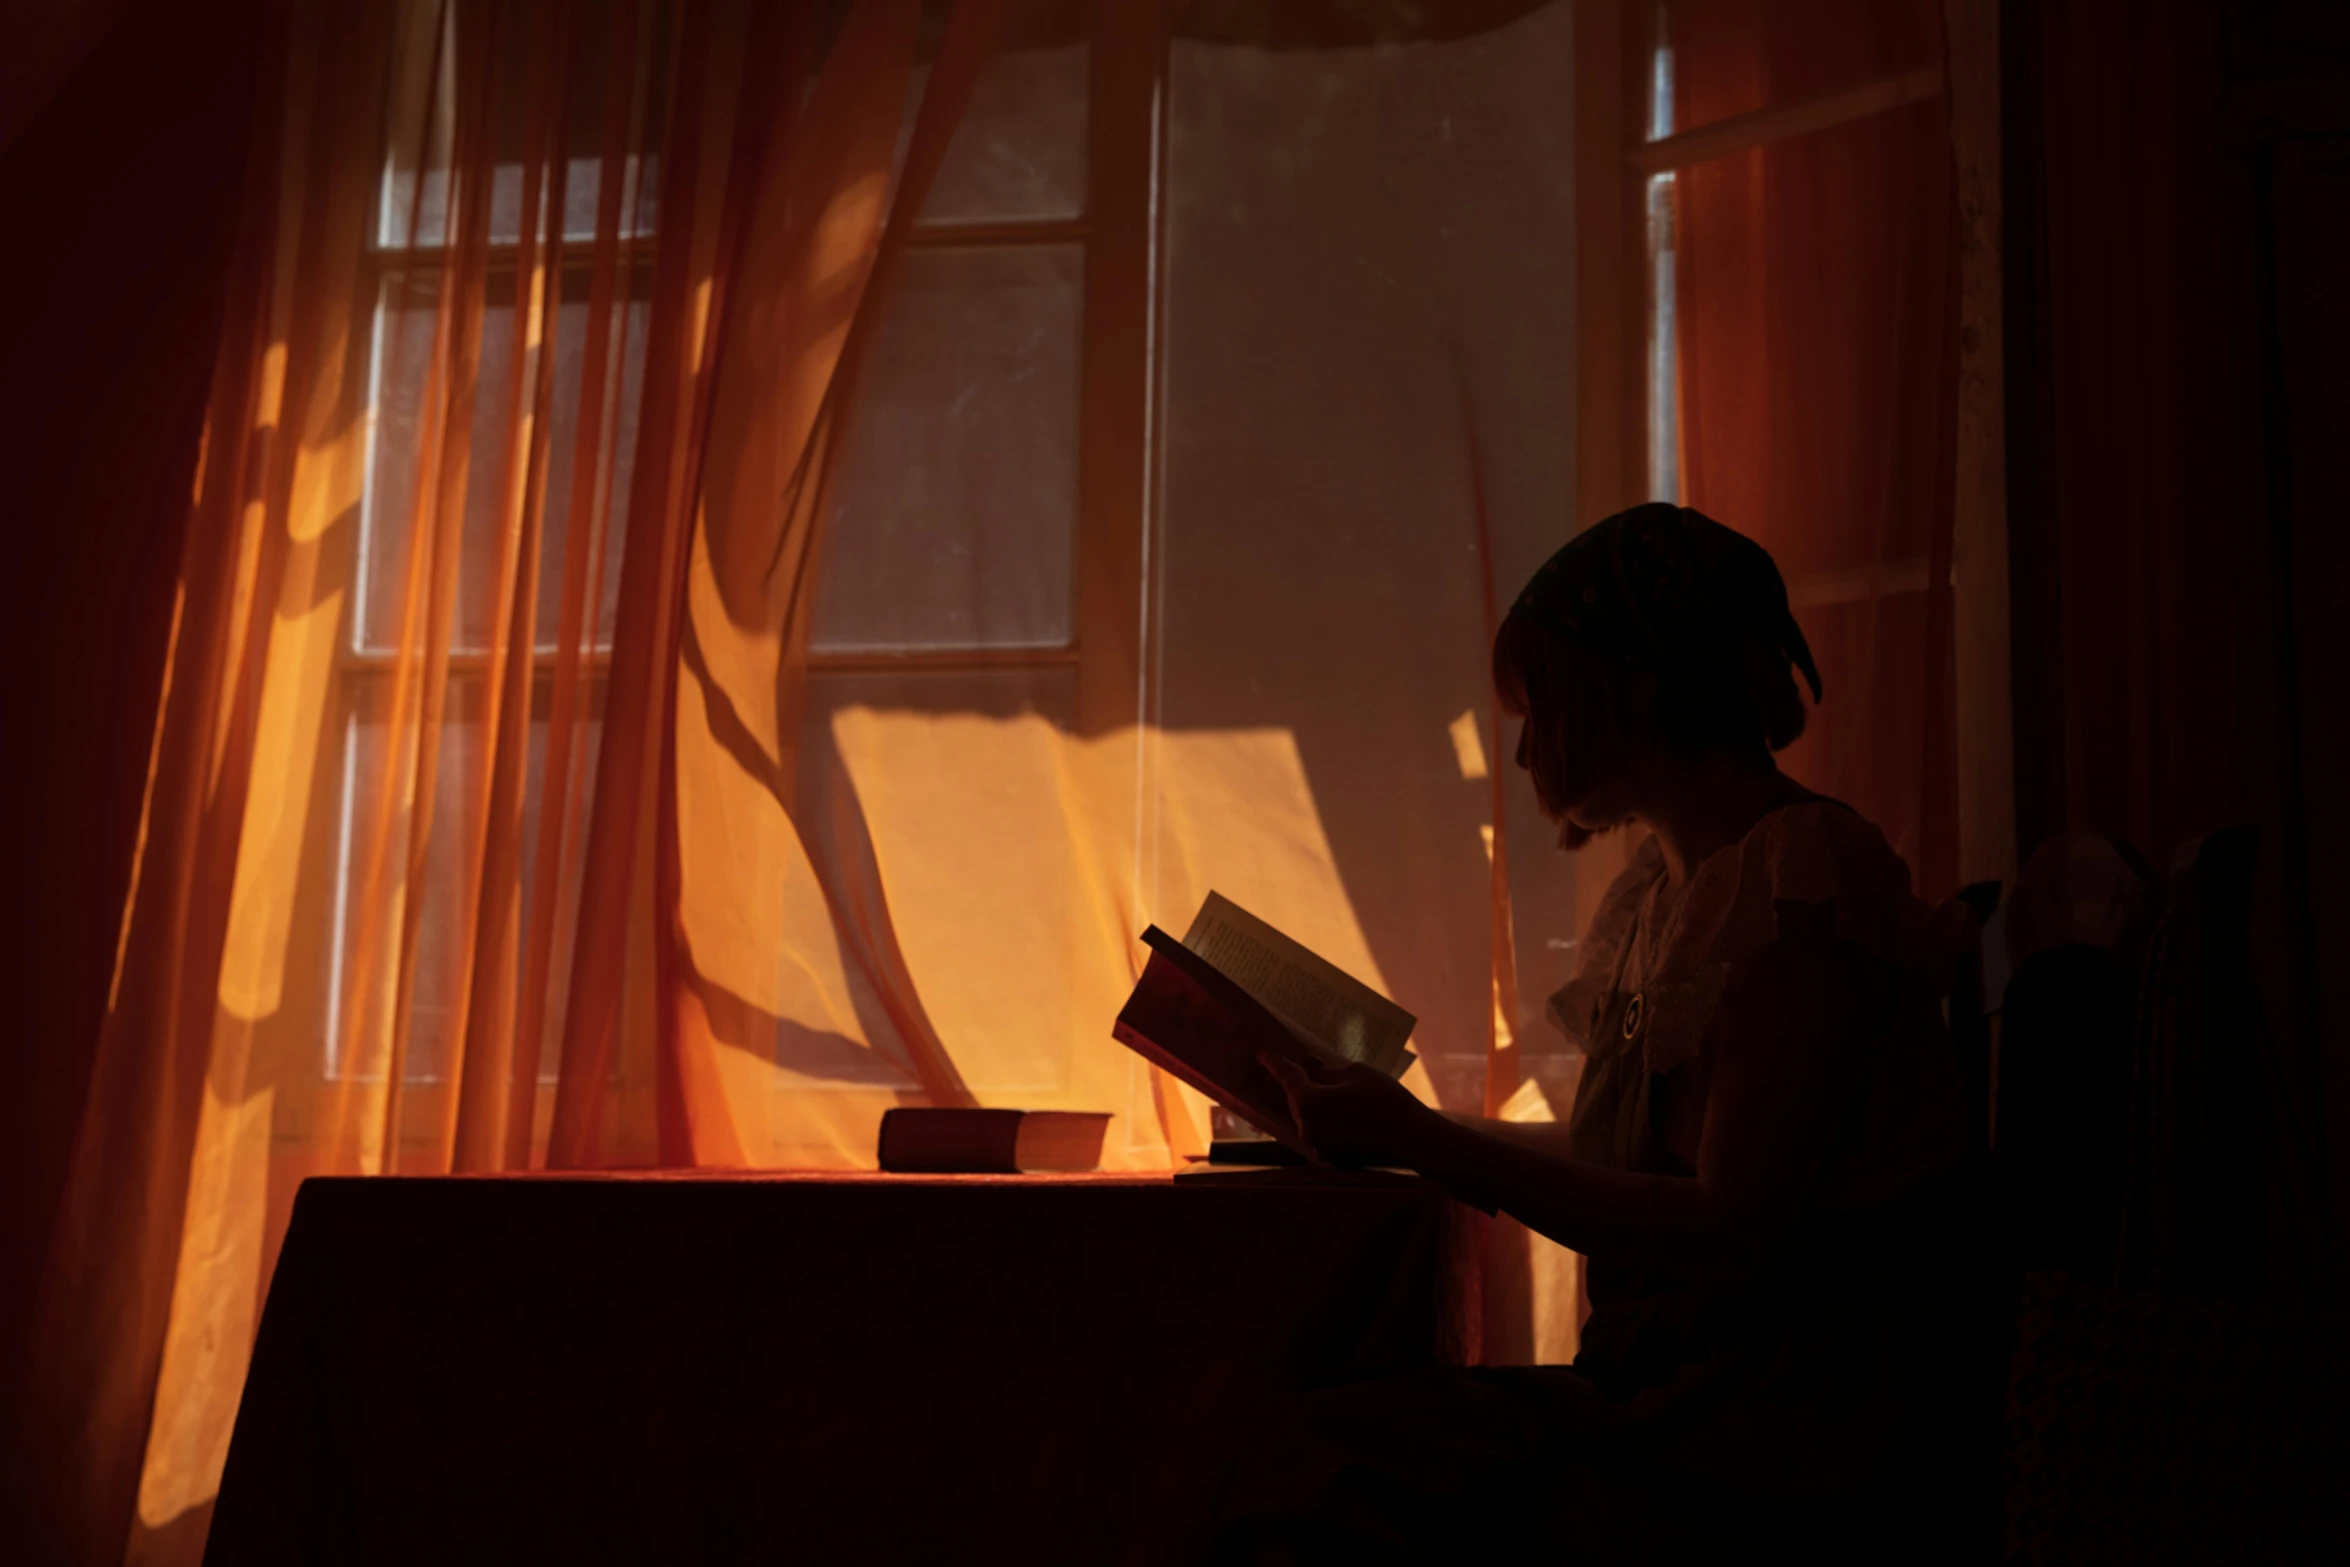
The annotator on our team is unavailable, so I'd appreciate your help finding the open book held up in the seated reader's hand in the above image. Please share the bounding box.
[1112,893,1417,1151]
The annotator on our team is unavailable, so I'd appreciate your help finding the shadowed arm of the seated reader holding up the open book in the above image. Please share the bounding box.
[1281,906,1875,1259]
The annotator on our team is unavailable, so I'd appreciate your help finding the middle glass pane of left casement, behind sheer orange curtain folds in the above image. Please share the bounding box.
[355,268,651,653]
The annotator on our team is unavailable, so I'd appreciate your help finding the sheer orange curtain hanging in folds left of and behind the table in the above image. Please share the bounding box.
[26,0,999,1560]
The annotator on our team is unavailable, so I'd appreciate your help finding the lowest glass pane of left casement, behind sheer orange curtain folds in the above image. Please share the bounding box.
[327,674,604,1083]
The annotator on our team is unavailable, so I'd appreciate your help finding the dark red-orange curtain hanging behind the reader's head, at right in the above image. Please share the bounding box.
[1664,0,1958,897]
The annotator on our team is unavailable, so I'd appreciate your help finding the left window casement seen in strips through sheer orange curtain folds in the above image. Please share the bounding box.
[322,5,665,1135]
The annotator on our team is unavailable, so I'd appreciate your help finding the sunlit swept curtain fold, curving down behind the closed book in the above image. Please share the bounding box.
[658,0,1001,1163]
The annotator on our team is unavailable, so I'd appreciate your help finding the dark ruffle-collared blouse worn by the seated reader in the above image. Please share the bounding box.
[1551,799,1967,1497]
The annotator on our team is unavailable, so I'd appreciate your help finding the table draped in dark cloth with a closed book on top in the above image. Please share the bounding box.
[207,1172,1473,1567]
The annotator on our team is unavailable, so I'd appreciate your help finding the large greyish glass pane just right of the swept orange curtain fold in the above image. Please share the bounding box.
[813,244,1083,651]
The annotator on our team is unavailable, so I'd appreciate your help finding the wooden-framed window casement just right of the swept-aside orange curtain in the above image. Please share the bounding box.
[811,0,1161,721]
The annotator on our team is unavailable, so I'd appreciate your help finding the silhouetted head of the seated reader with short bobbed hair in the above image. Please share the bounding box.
[1492,503,1821,848]
